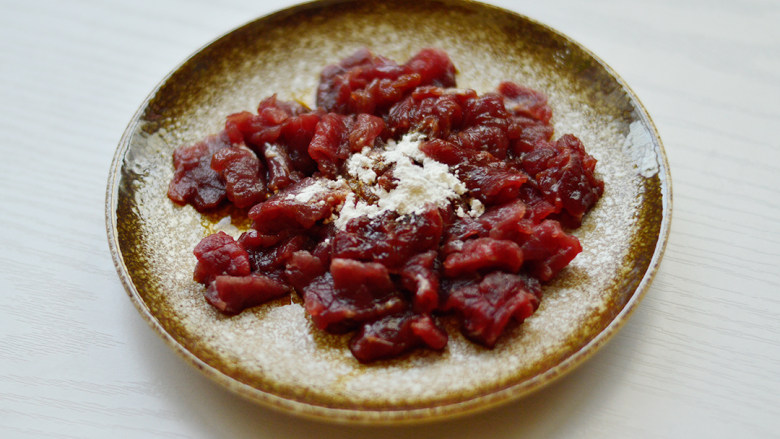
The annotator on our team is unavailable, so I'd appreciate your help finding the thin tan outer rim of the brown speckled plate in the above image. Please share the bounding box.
[105,0,673,425]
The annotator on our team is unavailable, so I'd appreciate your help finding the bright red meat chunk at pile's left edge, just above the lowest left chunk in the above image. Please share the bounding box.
[193,232,251,285]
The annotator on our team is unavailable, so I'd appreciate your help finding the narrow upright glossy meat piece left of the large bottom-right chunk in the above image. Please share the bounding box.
[400,250,439,313]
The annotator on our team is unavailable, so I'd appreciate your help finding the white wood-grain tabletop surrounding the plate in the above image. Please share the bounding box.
[0,0,780,439]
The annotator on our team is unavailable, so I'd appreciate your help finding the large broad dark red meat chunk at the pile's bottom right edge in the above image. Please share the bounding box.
[445,271,541,348]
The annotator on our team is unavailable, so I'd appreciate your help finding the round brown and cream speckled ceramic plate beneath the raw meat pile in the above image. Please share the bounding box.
[106,0,671,423]
